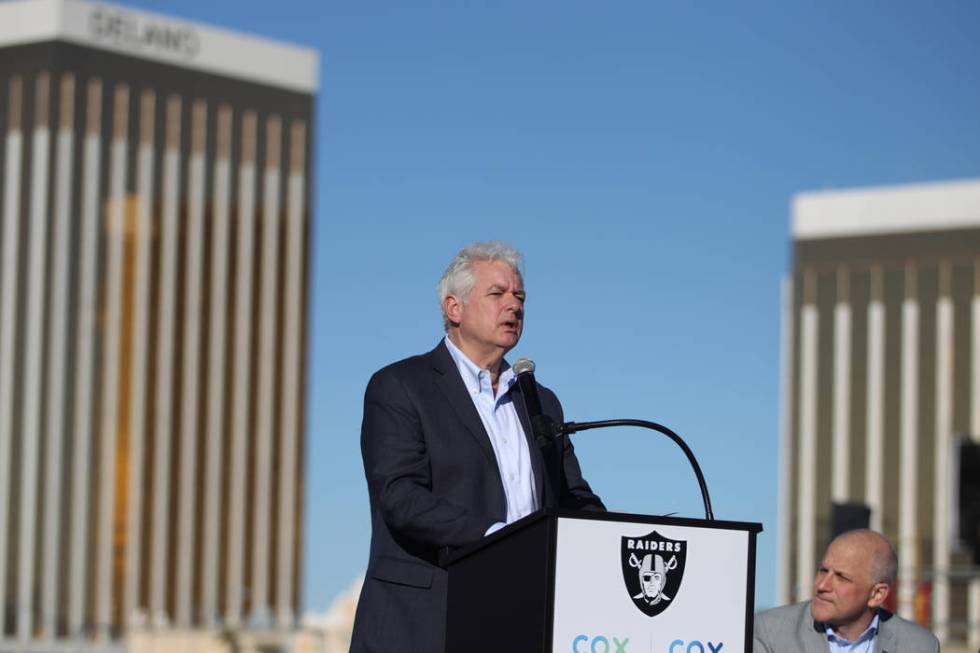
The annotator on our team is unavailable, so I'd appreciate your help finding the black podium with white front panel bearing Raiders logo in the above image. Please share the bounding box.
[446,509,762,653]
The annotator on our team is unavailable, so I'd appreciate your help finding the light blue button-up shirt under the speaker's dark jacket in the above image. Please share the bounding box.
[445,336,538,535]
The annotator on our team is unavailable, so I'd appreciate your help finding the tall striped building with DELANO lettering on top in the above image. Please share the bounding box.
[0,0,318,650]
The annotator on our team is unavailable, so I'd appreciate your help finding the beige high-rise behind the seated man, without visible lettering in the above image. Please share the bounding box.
[778,180,980,649]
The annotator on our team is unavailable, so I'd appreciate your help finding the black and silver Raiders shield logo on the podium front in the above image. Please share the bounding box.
[622,531,687,617]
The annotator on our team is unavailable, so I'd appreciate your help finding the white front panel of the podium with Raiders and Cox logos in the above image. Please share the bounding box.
[551,517,754,653]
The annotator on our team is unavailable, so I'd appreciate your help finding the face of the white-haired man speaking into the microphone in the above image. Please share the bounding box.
[448,261,525,356]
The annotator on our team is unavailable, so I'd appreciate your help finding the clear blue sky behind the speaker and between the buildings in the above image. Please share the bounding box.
[130,0,980,611]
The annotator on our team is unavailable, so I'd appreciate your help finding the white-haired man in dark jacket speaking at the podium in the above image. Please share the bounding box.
[351,242,604,653]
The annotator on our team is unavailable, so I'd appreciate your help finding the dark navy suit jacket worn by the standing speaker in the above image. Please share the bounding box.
[351,342,603,653]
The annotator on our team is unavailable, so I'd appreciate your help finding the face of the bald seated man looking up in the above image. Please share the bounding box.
[811,537,888,628]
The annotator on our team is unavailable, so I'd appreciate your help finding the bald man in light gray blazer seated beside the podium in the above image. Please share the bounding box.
[753,530,939,653]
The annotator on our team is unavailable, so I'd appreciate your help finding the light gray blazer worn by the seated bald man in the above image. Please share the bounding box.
[752,601,939,653]
